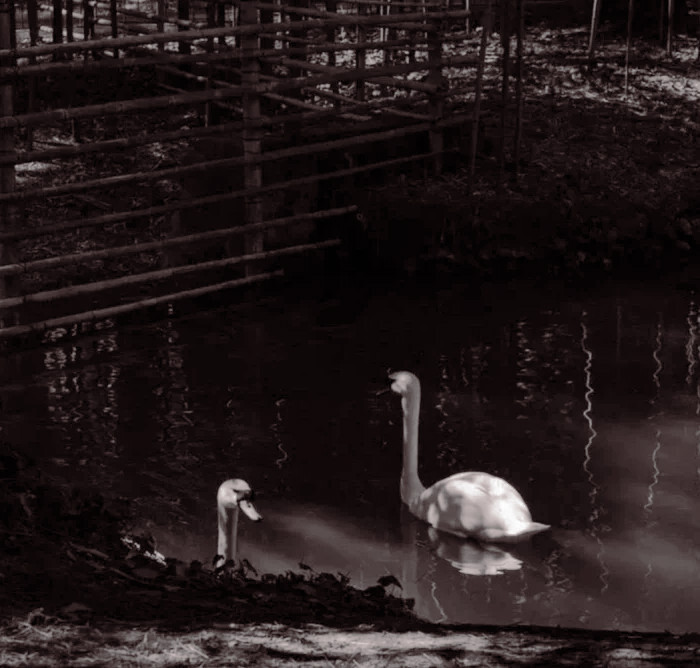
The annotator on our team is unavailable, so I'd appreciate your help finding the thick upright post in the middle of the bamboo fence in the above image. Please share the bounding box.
[238,0,264,268]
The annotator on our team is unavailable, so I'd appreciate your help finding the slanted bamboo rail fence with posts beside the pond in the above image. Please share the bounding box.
[0,0,492,338]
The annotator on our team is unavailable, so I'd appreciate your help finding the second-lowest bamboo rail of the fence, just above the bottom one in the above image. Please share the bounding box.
[0,239,340,309]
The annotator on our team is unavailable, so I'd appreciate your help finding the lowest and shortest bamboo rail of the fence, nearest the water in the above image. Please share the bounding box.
[0,270,284,338]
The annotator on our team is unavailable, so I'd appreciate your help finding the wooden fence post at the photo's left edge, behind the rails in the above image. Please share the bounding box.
[0,0,17,310]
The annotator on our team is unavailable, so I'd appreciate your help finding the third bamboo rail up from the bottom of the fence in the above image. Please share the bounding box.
[0,205,357,277]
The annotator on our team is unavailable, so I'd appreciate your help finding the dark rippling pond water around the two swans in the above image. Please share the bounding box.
[0,278,700,632]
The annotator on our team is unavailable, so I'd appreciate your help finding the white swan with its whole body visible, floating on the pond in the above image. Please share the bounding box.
[389,371,549,543]
